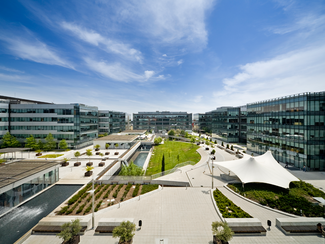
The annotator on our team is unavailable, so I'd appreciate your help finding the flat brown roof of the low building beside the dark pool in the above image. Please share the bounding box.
[0,160,62,188]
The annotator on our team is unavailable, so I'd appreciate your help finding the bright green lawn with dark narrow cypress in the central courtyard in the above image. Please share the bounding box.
[146,141,201,175]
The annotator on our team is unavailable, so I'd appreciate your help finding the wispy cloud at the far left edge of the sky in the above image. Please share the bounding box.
[0,31,74,69]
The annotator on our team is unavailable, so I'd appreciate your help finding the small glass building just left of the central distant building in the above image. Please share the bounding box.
[99,110,125,134]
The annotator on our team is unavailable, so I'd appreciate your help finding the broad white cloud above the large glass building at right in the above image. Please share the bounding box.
[214,45,325,105]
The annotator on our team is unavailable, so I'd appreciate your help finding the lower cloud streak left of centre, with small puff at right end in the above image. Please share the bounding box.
[84,58,165,82]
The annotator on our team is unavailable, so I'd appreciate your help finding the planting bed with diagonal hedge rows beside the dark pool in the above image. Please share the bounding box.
[57,183,158,215]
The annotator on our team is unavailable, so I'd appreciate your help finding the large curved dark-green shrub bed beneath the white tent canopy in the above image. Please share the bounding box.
[228,181,325,217]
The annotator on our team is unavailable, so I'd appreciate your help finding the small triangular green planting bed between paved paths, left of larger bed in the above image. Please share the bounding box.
[213,189,252,218]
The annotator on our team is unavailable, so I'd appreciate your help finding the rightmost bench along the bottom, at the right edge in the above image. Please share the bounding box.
[276,217,325,235]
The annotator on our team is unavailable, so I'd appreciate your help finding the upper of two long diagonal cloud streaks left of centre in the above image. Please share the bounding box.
[61,22,142,63]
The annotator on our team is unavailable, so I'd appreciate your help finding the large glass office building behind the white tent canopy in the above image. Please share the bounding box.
[247,92,325,170]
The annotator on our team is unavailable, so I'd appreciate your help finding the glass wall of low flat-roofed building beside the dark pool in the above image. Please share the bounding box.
[0,168,59,213]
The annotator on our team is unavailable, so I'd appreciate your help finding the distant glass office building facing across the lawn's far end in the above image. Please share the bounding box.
[133,111,192,132]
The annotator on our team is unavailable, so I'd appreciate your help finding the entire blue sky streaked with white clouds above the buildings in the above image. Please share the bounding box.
[0,0,325,113]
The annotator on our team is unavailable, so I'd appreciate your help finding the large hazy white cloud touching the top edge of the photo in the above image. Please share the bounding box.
[119,0,214,49]
